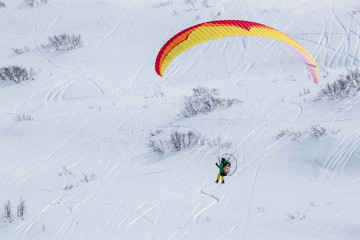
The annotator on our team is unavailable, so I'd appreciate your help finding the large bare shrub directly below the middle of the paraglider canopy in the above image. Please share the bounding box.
[181,87,240,118]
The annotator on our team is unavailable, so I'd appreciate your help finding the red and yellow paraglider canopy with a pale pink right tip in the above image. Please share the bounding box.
[155,20,320,83]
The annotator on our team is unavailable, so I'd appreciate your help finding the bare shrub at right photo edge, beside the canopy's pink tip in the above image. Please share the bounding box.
[319,69,360,100]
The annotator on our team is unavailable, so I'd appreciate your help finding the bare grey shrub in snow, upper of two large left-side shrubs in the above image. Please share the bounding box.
[43,33,83,51]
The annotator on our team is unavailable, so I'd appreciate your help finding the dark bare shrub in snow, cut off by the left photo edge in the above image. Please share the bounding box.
[0,66,35,83]
